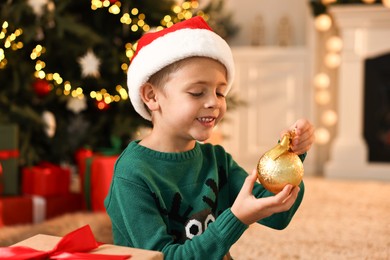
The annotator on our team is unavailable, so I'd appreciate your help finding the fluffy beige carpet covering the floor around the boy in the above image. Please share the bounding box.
[0,176,390,260]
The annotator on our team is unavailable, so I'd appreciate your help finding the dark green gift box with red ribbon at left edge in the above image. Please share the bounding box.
[0,125,20,195]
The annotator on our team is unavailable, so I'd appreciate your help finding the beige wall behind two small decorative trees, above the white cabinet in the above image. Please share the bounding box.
[225,0,309,46]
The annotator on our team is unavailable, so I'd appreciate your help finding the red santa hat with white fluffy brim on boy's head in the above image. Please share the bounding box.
[127,16,234,120]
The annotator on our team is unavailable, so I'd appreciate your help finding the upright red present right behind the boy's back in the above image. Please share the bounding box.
[82,155,118,211]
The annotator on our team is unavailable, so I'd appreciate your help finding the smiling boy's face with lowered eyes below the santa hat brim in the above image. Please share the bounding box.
[153,57,227,142]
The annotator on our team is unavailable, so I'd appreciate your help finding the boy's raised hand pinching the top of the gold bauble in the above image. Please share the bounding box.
[282,119,314,155]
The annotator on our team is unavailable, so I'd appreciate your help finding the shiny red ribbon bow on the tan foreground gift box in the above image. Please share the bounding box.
[0,225,130,260]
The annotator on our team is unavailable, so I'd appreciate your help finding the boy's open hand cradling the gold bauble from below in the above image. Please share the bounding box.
[231,169,299,225]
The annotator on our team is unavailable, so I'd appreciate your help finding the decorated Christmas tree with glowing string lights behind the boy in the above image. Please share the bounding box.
[0,0,237,166]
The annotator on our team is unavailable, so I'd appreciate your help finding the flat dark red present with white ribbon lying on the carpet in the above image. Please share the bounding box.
[0,193,83,227]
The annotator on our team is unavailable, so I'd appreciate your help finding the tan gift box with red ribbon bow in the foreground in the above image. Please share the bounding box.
[0,225,163,260]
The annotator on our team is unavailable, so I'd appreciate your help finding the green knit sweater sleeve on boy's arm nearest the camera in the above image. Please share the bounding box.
[106,177,247,259]
